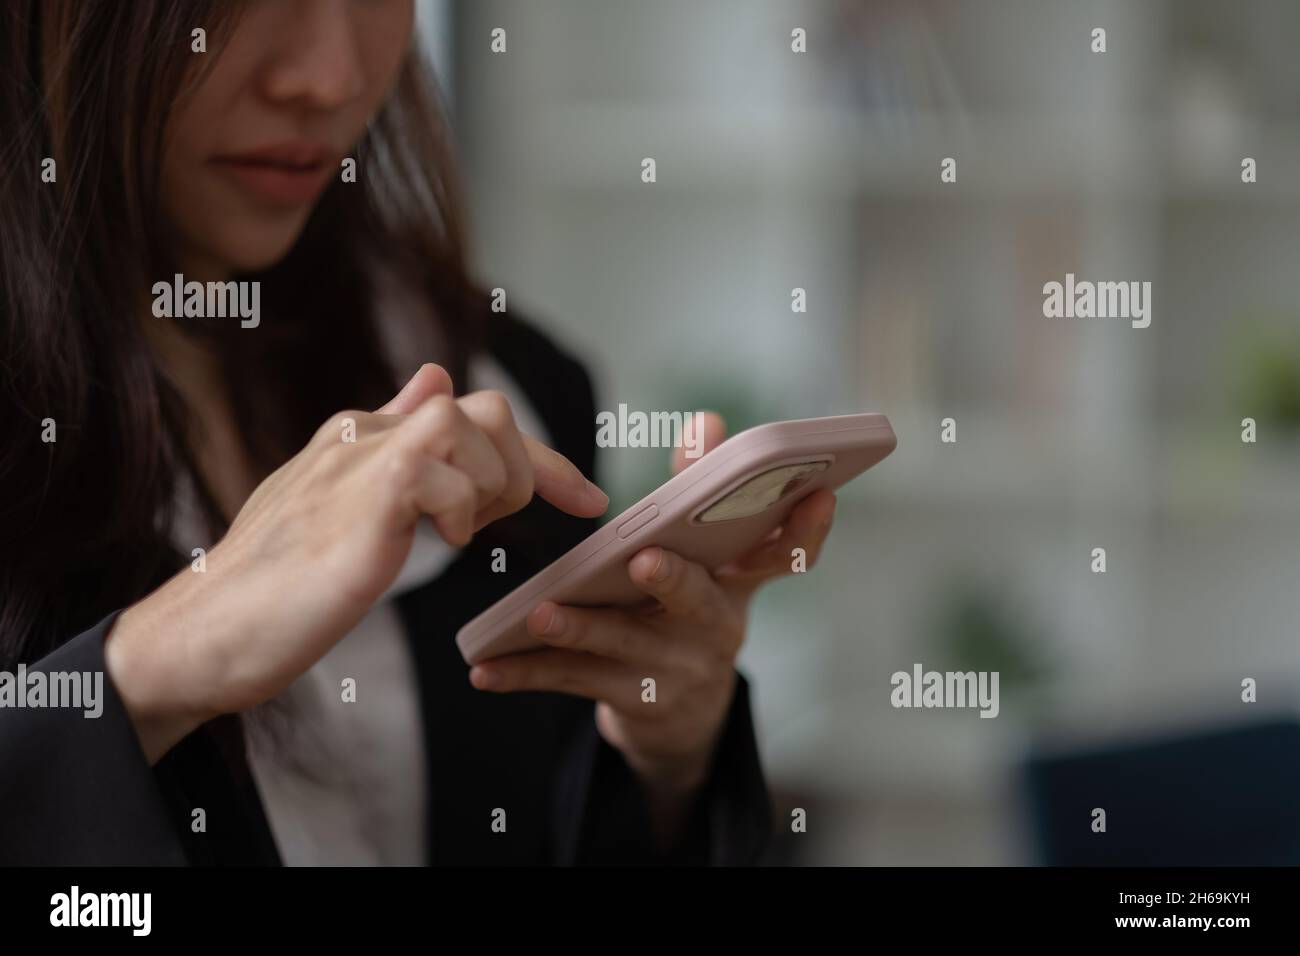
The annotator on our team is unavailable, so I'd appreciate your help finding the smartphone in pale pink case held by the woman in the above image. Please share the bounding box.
[456,415,898,665]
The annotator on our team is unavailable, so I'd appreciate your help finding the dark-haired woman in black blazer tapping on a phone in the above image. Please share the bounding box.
[0,0,835,864]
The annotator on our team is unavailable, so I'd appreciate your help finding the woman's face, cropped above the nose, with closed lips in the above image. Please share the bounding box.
[163,0,413,280]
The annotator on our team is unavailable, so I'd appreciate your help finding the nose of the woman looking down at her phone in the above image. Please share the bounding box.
[261,0,365,111]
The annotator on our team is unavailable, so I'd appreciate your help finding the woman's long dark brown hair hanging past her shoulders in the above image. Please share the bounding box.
[0,0,488,667]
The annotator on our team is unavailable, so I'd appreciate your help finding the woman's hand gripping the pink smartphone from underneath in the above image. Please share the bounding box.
[469,416,835,844]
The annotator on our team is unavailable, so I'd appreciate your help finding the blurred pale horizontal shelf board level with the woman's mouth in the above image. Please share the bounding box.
[476,101,1300,204]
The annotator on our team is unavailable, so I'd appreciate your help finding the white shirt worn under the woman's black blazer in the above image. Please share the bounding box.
[236,356,549,866]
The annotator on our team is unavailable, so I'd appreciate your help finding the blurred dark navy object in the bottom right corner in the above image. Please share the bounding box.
[1026,721,1300,866]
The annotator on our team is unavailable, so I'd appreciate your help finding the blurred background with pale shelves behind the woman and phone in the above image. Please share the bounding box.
[421,0,1300,865]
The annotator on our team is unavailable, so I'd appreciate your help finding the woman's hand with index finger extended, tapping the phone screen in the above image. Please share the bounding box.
[104,365,608,761]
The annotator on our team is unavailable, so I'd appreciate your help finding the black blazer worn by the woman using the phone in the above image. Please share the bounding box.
[0,315,772,865]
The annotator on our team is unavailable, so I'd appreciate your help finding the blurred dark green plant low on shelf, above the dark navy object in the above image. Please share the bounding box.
[926,580,1049,698]
